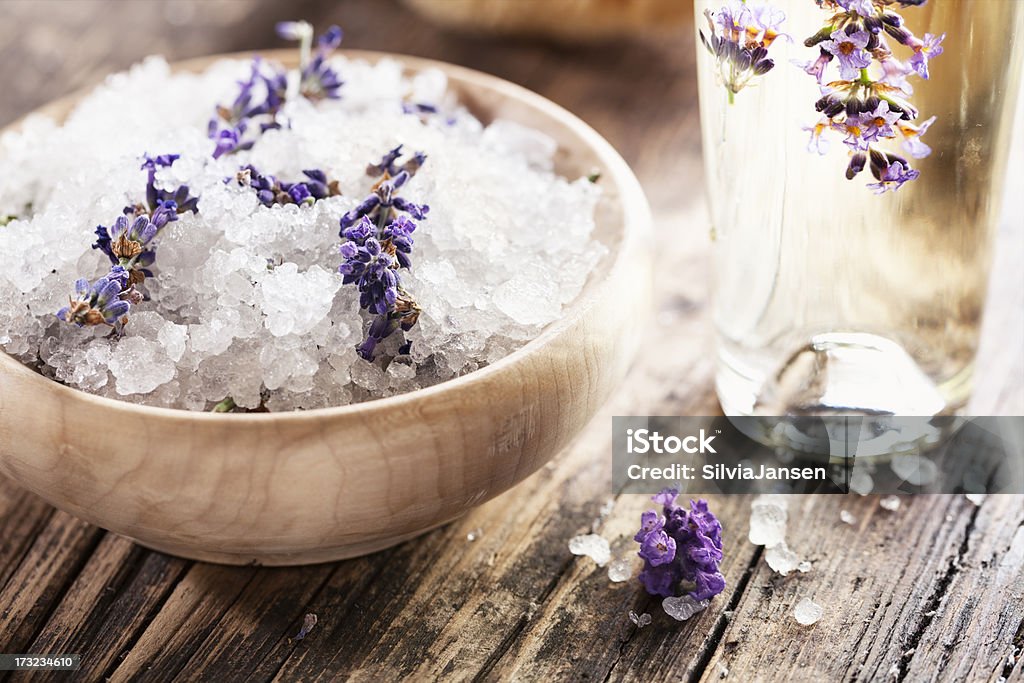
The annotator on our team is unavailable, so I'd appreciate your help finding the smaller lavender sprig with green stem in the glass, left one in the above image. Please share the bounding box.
[697,0,788,104]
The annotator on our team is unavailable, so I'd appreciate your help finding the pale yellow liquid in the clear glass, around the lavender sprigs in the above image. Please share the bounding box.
[695,0,1024,415]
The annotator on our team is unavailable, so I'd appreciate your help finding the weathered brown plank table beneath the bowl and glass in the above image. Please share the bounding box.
[0,0,1024,682]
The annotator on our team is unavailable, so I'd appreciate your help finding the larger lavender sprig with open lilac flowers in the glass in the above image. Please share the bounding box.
[798,0,945,195]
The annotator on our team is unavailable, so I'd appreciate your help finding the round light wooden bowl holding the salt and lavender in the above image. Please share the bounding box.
[0,50,651,565]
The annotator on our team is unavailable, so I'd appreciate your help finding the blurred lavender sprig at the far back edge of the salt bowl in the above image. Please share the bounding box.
[208,22,344,159]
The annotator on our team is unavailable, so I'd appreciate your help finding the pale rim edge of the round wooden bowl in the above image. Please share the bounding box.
[0,49,651,426]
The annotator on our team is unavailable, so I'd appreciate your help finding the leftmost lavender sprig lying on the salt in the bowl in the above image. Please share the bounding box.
[56,155,199,327]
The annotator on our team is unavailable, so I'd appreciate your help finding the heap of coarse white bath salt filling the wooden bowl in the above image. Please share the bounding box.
[0,55,607,411]
